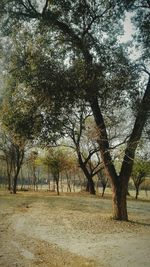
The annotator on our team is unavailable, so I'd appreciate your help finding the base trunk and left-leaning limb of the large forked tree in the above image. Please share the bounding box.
[90,98,128,221]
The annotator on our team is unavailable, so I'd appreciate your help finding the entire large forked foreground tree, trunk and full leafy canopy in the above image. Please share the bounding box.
[0,0,150,220]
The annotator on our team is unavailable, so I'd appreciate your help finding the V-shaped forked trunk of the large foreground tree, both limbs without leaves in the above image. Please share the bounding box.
[89,74,150,221]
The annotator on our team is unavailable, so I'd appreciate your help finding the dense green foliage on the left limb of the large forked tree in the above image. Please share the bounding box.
[0,1,140,118]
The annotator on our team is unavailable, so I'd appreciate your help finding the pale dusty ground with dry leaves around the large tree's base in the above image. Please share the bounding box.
[0,192,150,267]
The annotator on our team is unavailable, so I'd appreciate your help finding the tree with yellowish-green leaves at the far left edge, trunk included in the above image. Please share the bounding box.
[0,89,30,194]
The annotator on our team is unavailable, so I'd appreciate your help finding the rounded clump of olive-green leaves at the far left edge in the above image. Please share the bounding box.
[1,91,42,139]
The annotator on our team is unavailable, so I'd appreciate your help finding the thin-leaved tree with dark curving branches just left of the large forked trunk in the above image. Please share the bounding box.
[64,103,101,195]
